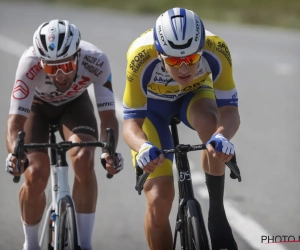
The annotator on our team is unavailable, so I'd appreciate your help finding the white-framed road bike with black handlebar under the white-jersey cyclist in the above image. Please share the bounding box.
[13,124,117,250]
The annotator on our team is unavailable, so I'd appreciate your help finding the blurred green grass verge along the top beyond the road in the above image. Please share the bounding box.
[4,0,300,29]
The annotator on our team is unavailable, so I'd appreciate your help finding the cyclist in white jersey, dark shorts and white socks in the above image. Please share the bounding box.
[6,20,123,250]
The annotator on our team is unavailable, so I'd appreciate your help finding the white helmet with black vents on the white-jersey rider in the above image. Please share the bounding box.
[33,19,81,61]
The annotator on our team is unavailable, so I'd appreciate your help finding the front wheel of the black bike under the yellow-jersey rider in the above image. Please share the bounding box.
[185,200,210,250]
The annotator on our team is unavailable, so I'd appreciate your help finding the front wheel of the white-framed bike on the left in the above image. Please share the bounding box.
[58,195,81,250]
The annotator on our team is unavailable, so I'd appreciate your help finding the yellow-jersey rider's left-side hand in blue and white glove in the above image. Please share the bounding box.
[136,142,165,173]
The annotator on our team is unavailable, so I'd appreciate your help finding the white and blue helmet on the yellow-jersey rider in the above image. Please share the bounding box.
[153,8,205,57]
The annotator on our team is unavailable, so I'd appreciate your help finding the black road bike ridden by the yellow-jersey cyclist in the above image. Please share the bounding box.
[135,116,242,250]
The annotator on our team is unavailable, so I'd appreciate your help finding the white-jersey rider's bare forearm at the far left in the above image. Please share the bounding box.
[6,115,26,153]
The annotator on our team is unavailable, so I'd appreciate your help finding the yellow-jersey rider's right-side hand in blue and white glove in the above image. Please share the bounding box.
[206,134,234,162]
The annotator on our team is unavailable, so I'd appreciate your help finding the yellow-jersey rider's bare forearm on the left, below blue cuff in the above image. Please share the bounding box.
[123,119,148,152]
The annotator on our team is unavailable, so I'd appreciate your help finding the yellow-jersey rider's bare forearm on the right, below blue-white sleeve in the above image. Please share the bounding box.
[216,106,240,140]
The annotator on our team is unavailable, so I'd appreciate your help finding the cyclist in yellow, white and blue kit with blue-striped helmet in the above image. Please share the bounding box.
[123,8,240,250]
